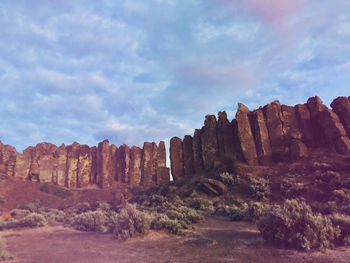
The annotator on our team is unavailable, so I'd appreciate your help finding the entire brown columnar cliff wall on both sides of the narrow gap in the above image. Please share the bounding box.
[0,97,350,188]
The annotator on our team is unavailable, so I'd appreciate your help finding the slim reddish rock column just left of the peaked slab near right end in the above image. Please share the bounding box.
[295,104,313,147]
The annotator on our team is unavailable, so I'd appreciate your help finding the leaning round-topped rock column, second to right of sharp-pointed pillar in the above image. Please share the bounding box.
[263,100,289,161]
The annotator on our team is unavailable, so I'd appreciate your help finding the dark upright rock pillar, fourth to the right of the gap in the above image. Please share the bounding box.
[201,115,218,170]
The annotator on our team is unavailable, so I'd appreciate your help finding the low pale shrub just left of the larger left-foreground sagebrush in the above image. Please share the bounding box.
[72,211,107,231]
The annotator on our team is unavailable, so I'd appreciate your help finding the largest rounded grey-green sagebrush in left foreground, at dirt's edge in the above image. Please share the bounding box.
[108,203,151,240]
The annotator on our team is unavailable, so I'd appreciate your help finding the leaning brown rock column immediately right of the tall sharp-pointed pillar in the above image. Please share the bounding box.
[249,108,272,165]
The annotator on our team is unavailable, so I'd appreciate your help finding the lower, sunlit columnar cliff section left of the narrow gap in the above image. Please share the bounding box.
[0,140,170,188]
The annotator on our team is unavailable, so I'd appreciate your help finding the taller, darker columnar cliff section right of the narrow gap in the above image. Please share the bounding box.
[170,96,350,180]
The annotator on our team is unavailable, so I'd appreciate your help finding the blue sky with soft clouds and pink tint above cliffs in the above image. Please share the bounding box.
[0,0,350,151]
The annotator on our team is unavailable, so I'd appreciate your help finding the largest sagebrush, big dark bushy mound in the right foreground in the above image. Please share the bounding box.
[258,199,340,250]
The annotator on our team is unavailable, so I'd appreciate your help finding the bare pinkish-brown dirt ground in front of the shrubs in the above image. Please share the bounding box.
[1,216,350,263]
